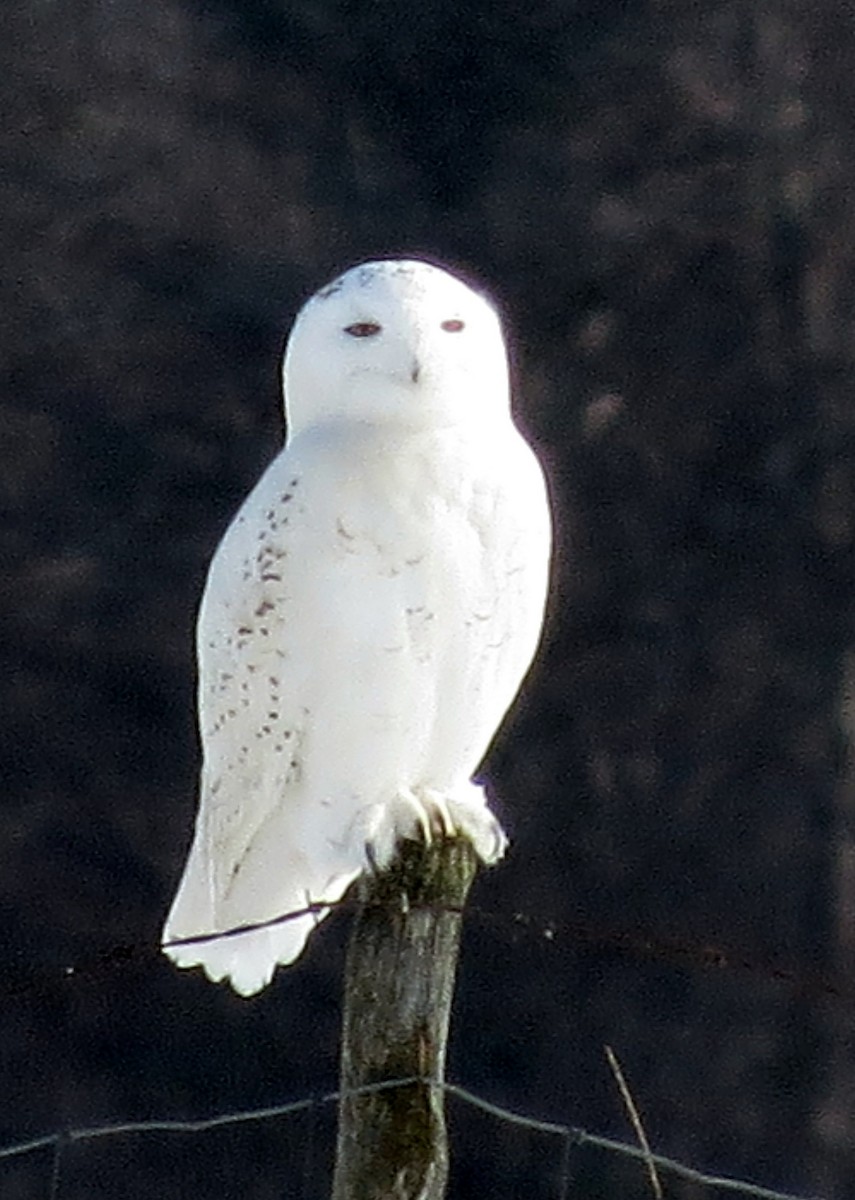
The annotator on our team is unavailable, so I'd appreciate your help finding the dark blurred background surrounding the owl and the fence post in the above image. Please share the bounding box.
[0,0,855,1200]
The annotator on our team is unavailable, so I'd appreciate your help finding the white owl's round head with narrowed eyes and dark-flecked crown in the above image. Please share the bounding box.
[283,260,509,437]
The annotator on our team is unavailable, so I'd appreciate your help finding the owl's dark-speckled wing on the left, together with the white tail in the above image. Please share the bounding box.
[163,441,361,995]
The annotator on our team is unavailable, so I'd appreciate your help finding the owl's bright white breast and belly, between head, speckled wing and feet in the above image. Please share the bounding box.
[278,427,549,790]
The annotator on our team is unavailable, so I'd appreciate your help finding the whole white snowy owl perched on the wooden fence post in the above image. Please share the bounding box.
[163,262,550,996]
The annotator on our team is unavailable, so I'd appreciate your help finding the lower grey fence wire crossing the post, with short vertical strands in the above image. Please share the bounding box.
[0,1075,817,1200]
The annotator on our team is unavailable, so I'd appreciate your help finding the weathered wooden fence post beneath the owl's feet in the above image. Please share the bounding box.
[333,839,477,1200]
